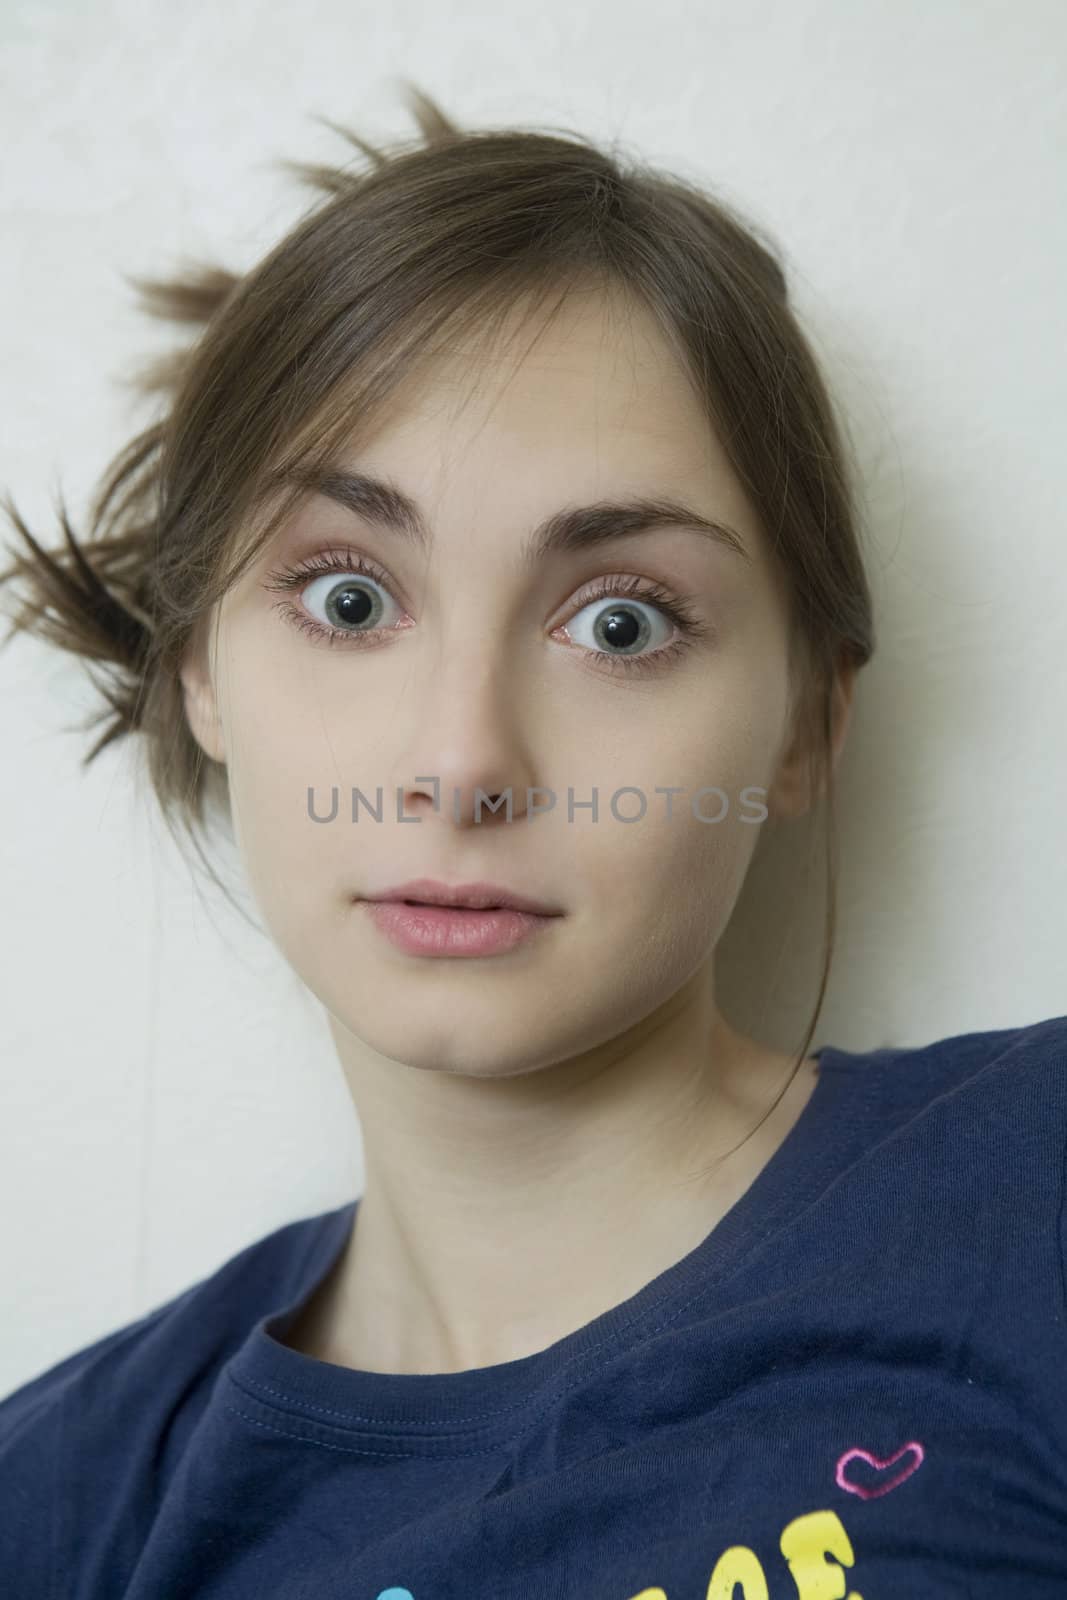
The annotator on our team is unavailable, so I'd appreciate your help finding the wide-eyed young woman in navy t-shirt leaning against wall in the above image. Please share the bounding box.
[0,84,1067,1600]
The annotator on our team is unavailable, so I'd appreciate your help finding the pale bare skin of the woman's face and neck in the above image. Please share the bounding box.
[182,281,853,1373]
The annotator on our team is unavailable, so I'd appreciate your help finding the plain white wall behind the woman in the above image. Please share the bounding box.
[0,0,1067,1392]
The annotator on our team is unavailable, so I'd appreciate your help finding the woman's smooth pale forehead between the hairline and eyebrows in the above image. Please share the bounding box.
[337,290,755,538]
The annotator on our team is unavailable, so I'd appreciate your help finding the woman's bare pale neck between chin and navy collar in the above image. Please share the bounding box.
[286,994,817,1373]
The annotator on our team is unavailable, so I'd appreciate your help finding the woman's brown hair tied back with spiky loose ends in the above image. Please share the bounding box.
[0,83,873,1139]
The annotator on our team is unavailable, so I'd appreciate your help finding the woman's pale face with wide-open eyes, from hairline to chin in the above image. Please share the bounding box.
[182,296,812,1077]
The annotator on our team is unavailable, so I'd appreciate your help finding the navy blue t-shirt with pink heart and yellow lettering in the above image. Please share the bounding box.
[0,1016,1067,1600]
